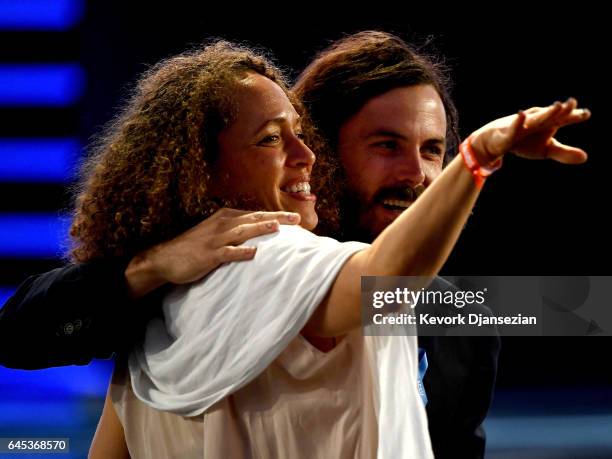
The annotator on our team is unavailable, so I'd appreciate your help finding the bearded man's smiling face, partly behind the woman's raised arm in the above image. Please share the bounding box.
[338,85,446,240]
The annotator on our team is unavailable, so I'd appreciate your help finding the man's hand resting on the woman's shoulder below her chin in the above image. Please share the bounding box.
[125,209,300,298]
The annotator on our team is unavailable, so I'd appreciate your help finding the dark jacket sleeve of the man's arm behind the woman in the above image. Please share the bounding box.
[0,260,160,370]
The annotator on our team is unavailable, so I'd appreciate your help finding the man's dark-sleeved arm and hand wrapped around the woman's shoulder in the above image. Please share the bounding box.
[0,209,299,369]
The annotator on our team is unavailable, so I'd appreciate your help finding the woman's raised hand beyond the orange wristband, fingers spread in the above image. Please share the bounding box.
[470,98,591,165]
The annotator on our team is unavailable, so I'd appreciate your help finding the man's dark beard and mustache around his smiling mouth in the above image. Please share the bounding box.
[340,185,424,243]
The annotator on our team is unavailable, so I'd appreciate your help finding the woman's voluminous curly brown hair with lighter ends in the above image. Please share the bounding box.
[70,41,340,262]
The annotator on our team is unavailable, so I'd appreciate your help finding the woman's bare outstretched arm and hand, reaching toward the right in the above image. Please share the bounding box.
[304,99,590,336]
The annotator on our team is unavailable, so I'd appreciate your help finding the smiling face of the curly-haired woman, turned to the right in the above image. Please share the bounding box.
[211,73,317,229]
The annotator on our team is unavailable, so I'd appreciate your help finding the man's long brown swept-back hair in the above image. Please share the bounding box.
[293,31,459,162]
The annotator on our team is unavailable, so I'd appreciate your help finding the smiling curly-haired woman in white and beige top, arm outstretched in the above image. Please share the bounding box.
[86,42,588,457]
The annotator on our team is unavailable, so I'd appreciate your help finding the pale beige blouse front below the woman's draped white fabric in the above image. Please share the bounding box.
[110,330,378,459]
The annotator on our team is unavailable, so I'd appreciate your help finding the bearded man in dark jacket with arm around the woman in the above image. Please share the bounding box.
[0,32,499,457]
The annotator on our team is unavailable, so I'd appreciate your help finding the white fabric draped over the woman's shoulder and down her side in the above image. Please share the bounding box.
[124,226,433,458]
